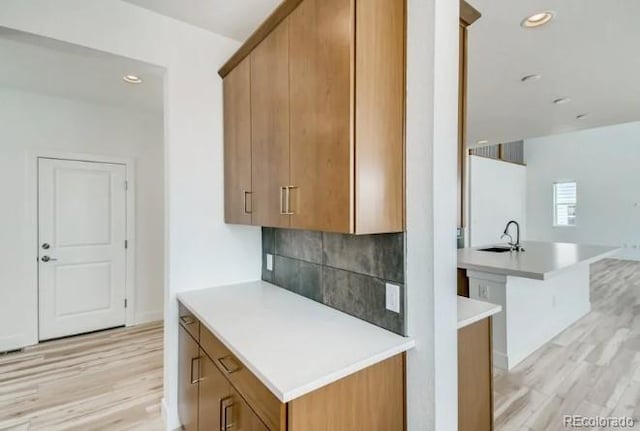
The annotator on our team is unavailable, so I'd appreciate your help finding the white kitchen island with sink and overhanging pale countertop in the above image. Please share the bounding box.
[458,241,617,370]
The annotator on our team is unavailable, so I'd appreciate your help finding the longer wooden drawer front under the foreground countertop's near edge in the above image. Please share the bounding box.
[200,326,287,431]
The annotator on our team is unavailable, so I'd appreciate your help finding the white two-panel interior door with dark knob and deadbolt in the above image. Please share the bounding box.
[38,158,126,340]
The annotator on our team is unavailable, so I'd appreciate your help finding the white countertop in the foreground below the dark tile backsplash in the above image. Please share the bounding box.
[178,281,415,403]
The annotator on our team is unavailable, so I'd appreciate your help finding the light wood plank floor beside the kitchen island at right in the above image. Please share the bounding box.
[495,259,640,431]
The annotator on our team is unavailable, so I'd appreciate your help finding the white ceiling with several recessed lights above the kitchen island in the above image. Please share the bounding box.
[467,0,640,145]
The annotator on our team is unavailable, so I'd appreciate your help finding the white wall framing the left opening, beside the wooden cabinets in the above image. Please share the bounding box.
[0,0,262,429]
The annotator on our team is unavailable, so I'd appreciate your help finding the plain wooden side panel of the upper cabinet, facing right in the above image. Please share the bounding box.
[354,0,405,234]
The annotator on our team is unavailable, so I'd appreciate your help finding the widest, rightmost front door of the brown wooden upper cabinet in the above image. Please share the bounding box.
[289,0,354,232]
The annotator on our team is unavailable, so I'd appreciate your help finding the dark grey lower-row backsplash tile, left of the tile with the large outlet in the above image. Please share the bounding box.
[273,255,322,302]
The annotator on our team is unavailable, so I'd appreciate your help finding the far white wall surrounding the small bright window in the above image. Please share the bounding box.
[524,122,640,254]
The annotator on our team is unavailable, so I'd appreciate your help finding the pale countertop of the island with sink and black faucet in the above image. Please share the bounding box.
[458,241,618,280]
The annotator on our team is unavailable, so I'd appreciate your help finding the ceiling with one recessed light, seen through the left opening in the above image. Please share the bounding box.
[0,27,164,113]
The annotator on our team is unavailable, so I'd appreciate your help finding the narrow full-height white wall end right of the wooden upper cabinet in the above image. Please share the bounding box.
[406,0,459,431]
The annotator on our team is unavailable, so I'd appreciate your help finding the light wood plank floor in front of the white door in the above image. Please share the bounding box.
[0,323,163,431]
